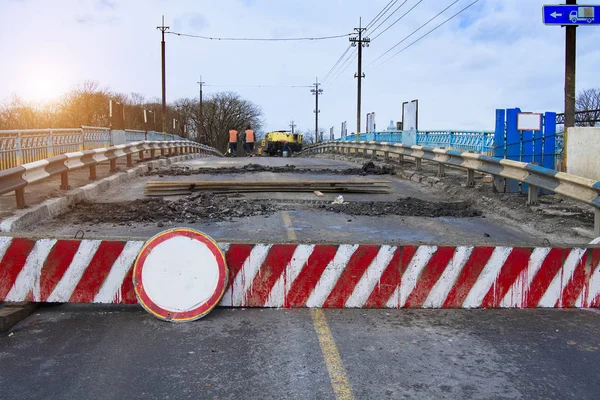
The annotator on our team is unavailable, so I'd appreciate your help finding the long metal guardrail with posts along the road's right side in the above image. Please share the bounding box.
[297,142,600,236]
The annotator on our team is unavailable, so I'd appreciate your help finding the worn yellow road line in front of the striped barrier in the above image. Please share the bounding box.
[310,308,354,400]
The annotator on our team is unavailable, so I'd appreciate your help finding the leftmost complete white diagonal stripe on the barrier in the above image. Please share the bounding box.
[6,239,56,301]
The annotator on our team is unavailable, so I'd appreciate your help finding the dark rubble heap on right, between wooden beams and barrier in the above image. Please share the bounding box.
[321,197,481,218]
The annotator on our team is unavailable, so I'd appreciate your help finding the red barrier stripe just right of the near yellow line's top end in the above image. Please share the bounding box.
[323,245,381,308]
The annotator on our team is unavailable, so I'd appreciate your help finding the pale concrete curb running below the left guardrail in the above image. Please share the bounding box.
[0,154,203,232]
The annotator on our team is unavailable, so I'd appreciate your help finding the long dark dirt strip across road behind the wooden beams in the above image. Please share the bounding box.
[146,161,396,176]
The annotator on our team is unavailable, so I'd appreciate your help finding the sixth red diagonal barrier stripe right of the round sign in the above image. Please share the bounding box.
[404,247,455,308]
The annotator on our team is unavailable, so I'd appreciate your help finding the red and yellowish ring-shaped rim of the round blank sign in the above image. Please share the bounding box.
[133,228,227,322]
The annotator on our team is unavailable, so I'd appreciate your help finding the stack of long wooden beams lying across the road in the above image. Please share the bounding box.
[145,179,390,196]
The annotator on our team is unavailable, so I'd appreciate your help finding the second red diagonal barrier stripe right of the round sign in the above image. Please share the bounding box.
[245,244,296,307]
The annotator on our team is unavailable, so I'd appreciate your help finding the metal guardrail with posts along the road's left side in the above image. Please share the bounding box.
[0,141,223,208]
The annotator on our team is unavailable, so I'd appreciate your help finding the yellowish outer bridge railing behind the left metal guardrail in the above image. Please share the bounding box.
[0,126,186,171]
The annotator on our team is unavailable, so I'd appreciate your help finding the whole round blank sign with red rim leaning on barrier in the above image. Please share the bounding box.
[133,228,227,322]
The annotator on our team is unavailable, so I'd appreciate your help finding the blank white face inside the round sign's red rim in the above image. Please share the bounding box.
[142,236,219,312]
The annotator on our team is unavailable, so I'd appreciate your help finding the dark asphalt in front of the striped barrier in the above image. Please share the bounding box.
[0,305,600,400]
